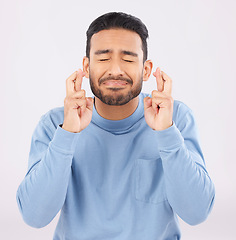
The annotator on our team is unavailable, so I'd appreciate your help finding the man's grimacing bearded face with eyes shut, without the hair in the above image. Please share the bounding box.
[82,29,146,106]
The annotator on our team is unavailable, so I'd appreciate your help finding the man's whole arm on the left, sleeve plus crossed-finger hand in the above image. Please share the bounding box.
[17,69,93,227]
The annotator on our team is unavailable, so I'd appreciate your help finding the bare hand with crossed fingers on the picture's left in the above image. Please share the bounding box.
[62,69,93,133]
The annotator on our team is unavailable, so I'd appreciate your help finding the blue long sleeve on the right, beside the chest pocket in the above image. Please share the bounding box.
[156,109,215,225]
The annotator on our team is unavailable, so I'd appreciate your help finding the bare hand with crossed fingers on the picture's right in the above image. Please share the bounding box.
[144,68,174,131]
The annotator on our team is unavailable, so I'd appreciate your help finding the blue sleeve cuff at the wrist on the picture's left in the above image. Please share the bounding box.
[51,125,80,152]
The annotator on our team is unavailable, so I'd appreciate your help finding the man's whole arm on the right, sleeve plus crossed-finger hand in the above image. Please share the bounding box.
[144,68,215,225]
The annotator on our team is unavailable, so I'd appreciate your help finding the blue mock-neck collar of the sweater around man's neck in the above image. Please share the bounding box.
[92,94,144,133]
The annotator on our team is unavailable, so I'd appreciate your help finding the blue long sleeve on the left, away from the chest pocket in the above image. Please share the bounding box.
[16,120,78,228]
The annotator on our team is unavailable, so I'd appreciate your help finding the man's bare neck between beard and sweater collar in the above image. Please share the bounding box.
[94,96,139,120]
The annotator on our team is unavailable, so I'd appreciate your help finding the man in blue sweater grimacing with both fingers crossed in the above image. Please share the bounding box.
[17,12,215,240]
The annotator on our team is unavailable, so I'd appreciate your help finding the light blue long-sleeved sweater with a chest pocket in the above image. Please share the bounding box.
[17,93,215,240]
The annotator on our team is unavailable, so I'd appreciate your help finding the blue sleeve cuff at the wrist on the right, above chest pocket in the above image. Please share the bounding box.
[153,121,184,151]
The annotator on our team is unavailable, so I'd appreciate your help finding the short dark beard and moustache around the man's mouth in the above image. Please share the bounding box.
[89,71,143,106]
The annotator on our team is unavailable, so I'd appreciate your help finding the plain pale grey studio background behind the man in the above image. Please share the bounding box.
[0,0,236,240]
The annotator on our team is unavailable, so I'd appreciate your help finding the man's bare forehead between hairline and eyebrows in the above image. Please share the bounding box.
[90,29,142,54]
